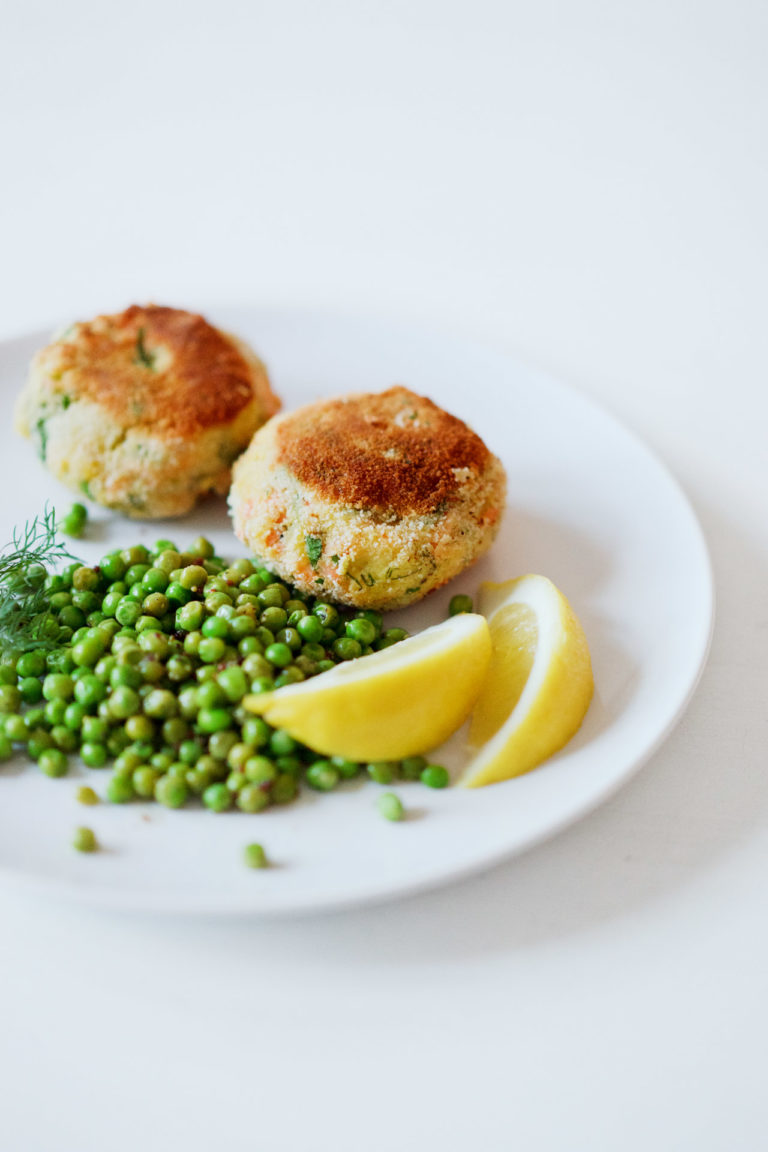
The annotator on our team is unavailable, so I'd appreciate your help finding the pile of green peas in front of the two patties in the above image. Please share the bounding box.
[0,537,448,812]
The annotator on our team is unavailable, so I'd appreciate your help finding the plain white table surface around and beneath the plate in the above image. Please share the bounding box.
[0,0,768,1152]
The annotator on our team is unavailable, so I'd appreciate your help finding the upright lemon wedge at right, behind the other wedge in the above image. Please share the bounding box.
[459,576,594,788]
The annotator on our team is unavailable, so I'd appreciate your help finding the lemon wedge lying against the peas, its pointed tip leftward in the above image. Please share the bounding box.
[243,613,491,760]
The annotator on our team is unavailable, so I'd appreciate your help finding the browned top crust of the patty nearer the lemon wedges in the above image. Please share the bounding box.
[276,387,491,516]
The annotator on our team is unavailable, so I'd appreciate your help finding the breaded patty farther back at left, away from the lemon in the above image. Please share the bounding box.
[16,304,280,518]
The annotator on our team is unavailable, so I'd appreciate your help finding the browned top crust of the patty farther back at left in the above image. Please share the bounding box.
[49,304,279,437]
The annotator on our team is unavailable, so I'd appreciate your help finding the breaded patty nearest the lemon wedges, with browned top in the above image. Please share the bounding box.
[229,387,505,608]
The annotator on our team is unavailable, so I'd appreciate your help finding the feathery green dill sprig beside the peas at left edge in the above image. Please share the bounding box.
[0,505,77,652]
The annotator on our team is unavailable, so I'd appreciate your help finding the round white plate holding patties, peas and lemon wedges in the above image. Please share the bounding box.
[0,310,713,914]
